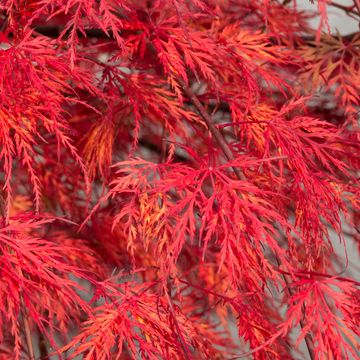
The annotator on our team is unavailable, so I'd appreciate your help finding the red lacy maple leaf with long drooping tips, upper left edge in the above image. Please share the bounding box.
[0,32,94,216]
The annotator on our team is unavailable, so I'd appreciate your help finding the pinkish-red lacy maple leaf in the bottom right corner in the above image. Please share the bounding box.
[279,277,360,359]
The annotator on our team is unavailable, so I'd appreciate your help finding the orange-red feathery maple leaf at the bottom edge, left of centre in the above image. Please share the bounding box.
[61,283,228,359]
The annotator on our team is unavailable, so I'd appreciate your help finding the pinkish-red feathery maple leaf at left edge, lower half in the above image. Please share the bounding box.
[0,213,94,359]
